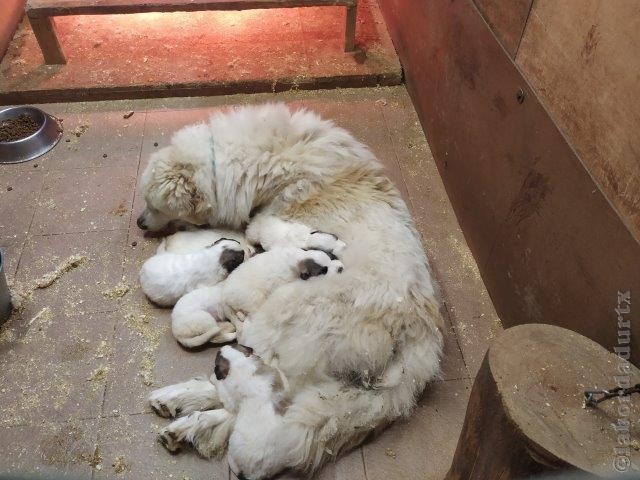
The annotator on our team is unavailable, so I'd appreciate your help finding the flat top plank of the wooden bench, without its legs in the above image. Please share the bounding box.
[26,0,357,17]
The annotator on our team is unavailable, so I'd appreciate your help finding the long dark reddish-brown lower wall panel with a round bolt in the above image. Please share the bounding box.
[381,0,640,362]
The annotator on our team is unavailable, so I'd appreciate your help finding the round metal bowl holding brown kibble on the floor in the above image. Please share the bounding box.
[0,107,62,163]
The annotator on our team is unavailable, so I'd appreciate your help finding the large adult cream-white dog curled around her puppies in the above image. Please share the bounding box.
[138,105,442,479]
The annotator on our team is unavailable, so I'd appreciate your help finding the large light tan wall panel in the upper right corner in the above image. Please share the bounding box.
[517,0,640,239]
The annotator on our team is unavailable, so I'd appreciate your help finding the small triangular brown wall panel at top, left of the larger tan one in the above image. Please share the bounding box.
[474,0,533,58]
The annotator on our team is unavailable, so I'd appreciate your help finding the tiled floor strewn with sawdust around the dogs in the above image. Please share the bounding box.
[0,87,501,480]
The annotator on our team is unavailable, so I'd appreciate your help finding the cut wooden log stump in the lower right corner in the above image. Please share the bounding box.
[446,317,640,480]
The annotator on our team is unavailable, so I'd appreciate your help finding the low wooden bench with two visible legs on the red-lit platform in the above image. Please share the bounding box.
[26,0,358,65]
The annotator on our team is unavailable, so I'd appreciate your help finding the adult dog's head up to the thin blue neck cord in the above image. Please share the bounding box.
[138,124,216,231]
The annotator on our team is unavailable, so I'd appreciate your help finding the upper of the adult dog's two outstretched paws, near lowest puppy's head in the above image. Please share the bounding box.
[148,378,219,418]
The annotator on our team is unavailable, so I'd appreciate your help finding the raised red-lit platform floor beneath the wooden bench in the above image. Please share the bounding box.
[0,0,401,103]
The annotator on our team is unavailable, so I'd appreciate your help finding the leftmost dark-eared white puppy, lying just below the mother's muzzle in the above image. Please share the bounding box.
[140,238,244,306]
